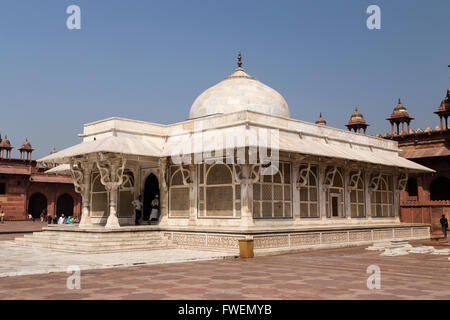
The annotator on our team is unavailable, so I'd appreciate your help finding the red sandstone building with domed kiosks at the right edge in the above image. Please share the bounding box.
[383,90,450,234]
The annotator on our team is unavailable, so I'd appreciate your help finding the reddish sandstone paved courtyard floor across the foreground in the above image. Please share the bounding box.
[0,242,450,300]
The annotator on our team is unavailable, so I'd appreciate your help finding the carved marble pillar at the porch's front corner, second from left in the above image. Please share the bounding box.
[96,153,126,229]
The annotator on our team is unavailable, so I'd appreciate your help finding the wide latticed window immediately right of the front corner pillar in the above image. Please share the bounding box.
[253,162,292,219]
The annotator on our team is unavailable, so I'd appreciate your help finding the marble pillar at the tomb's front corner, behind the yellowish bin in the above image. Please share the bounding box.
[234,164,260,228]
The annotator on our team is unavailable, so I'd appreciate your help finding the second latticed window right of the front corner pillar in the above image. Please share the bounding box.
[299,165,319,218]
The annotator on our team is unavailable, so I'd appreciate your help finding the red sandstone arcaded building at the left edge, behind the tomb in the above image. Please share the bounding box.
[0,136,81,220]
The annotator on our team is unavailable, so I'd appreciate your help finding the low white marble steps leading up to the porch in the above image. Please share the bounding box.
[10,231,175,253]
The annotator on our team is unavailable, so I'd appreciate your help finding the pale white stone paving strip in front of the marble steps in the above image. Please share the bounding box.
[0,242,235,278]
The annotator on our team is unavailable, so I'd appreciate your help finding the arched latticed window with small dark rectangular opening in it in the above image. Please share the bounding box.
[325,168,345,218]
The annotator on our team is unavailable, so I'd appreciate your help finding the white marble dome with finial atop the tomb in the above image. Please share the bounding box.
[189,53,291,119]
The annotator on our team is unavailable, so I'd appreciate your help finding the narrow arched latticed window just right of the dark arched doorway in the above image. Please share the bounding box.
[169,166,190,218]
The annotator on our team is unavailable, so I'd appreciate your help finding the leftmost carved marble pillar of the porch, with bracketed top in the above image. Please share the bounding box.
[70,159,92,228]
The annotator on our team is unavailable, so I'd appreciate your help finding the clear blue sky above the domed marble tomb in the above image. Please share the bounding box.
[0,0,450,158]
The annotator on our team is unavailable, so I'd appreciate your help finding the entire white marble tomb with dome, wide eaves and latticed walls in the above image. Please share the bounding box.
[38,54,433,254]
